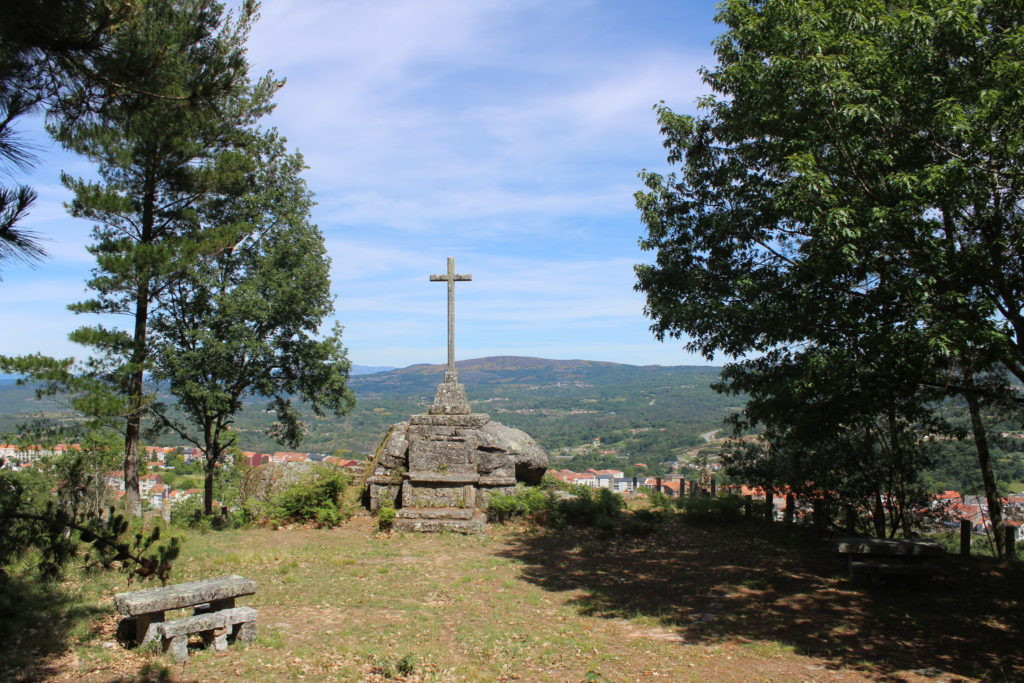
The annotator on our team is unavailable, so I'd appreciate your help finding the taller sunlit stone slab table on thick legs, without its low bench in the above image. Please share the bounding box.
[114,574,256,645]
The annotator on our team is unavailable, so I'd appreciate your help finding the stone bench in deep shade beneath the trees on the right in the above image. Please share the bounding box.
[836,538,942,583]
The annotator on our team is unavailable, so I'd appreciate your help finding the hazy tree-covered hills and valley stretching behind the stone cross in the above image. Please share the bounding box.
[0,356,742,462]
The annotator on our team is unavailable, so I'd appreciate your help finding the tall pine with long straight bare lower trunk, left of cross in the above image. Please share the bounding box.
[51,0,281,514]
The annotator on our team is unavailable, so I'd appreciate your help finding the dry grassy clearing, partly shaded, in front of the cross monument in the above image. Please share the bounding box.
[0,516,1024,681]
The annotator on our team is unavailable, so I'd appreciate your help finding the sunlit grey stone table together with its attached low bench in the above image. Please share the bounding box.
[114,574,257,661]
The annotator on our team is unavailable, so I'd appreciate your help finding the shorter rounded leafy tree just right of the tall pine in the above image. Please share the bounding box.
[153,133,354,514]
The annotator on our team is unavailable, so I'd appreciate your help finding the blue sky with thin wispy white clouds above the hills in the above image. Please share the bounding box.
[0,0,720,367]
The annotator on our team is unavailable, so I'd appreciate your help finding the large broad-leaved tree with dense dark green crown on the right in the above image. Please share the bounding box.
[637,0,1024,552]
